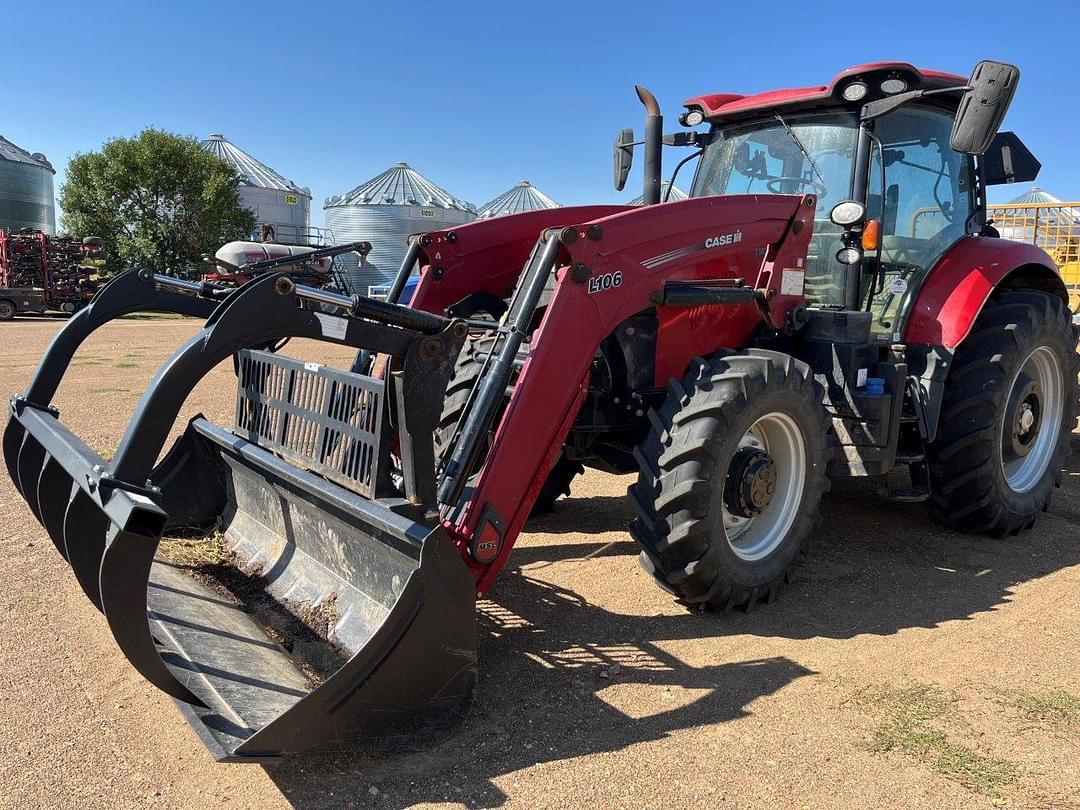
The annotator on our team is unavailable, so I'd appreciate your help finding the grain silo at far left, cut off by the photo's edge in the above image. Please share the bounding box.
[0,135,56,233]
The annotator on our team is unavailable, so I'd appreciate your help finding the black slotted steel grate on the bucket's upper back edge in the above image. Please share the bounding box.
[233,350,384,498]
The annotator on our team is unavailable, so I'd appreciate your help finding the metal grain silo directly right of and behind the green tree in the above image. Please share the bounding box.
[202,134,313,245]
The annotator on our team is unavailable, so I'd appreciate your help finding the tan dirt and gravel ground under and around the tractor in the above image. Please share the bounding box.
[0,320,1080,808]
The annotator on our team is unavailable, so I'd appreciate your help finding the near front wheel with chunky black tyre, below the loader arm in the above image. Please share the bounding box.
[630,349,829,609]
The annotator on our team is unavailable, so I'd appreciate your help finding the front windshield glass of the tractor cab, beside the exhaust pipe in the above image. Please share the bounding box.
[692,110,859,303]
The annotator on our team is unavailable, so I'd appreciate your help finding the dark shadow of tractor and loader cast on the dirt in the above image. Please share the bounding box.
[266,440,1080,808]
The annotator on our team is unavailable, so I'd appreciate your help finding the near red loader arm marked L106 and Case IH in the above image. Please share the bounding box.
[448,195,816,593]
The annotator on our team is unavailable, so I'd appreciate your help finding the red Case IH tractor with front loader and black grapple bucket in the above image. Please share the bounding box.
[3,62,1078,761]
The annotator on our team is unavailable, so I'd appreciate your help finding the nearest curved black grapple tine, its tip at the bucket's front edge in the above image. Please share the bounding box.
[99,526,206,707]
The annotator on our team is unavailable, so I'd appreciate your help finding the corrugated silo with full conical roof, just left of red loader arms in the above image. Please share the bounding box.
[323,163,476,295]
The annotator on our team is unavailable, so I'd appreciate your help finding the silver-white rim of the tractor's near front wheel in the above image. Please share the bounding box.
[723,411,807,563]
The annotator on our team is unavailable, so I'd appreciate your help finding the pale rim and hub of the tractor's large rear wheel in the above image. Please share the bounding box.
[1001,346,1065,492]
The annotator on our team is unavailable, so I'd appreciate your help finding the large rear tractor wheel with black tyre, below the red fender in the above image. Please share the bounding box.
[928,289,1080,537]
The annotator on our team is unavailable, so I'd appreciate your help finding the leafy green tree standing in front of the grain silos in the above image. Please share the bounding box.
[60,129,255,275]
